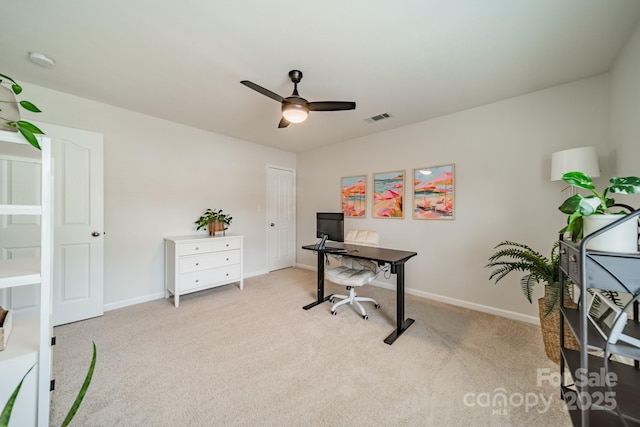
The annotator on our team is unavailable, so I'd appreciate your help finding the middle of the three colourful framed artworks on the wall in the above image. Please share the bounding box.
[372,170,404,218]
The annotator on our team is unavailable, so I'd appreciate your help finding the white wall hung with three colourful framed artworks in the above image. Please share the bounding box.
[297,75,609,322]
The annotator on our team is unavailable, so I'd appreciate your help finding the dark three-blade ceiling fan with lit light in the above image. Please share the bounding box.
[240,70,356,128]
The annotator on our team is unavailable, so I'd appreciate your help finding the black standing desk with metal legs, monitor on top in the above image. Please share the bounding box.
[302,242,418,344]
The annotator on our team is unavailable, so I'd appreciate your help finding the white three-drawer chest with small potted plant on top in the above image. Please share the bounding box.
[164,235,243,307]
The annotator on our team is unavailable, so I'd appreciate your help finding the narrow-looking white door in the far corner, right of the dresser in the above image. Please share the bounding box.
[267,166,296,271]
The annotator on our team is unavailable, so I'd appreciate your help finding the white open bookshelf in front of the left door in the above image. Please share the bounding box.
[0,131,53,426]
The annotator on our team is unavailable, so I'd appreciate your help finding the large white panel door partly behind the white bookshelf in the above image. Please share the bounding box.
[0,123,104,326]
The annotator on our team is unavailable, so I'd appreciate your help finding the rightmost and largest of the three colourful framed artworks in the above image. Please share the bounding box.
[413,164,455,219]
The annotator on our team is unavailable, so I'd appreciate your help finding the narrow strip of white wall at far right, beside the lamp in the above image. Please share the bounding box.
[611,21,640,197]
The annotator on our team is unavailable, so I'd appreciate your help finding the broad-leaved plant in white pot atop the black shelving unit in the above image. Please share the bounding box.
[558,172,640,252]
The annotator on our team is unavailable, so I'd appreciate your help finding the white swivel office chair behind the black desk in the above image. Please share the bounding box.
[325,230,380,320]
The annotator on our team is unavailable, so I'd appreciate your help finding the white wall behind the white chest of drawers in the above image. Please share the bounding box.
[21,82,296,309]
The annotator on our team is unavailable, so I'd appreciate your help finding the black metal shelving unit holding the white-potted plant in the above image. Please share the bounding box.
[560,209,640,427]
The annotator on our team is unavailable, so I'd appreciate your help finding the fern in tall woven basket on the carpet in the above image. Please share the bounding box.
[485,240,579,363]
